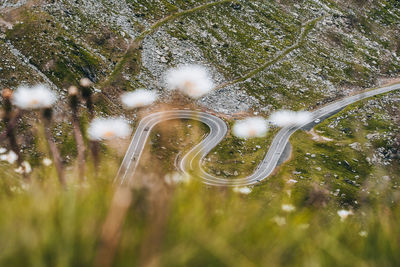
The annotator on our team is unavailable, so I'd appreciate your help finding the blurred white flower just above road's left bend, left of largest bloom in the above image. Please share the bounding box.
[121,89,157,109]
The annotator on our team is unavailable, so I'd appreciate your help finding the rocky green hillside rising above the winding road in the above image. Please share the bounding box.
[0,0,400,114]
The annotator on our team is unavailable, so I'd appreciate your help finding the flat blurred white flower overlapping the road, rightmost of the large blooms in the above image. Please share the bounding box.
[269,110,312,127]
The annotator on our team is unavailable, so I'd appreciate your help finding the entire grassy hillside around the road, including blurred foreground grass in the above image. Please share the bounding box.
[0,0,400,267]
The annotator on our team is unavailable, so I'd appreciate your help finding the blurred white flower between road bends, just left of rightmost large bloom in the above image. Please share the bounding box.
[232,117,268,138]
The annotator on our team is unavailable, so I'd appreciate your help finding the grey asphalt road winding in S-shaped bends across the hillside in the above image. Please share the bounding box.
[116,84,400,186]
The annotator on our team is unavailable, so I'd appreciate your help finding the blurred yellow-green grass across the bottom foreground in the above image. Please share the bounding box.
[0,148,400,266]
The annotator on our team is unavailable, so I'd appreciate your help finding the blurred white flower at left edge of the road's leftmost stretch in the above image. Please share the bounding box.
[88,118,131,140]
